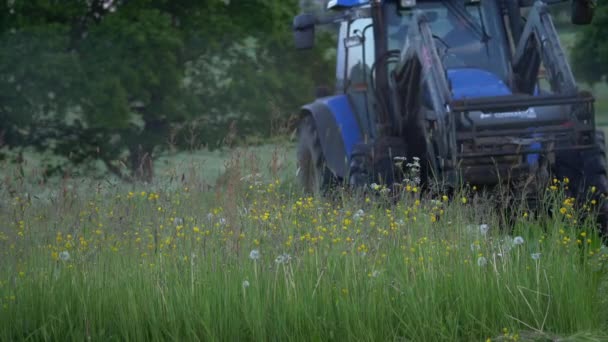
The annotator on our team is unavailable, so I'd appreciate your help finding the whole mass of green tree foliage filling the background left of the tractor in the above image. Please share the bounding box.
[0,0,332,179]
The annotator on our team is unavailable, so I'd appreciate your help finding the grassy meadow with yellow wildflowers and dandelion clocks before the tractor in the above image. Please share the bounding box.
[0,145,608,341]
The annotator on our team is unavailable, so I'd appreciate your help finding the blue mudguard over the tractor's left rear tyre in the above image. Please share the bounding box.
[301,95,361,179]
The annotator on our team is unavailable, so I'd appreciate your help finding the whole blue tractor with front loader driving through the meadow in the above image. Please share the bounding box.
[293,0,608,229]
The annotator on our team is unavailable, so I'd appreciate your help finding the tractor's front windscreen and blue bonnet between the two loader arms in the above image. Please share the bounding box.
[385,1,511,99]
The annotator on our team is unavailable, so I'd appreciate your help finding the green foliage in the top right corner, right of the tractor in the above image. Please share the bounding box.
[571,1,608,83]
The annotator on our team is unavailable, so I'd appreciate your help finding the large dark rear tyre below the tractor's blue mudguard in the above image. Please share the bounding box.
[297,115,337,195]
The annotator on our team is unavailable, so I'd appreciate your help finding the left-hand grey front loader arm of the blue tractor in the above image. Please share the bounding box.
[390,11,453,182]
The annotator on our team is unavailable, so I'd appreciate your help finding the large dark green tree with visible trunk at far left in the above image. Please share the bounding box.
[0,0,184,180]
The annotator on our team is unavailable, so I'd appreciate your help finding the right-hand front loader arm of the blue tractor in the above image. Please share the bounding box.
[513,1,578,95]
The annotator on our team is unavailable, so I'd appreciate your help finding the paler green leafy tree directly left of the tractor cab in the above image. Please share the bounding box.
[187,1,335,147]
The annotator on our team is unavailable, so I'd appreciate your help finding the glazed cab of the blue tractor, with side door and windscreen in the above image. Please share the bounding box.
[329,0,512,137]
